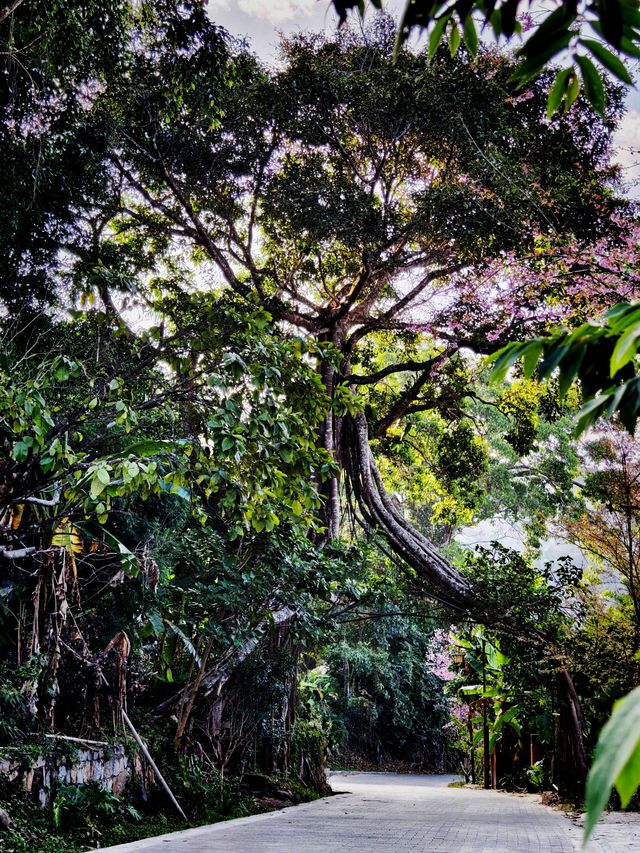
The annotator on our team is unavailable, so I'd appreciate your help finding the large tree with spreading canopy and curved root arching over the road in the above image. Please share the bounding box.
[5,3,632,796]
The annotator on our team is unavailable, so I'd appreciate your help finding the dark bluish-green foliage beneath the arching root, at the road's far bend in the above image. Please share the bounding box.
[316,611,457,772]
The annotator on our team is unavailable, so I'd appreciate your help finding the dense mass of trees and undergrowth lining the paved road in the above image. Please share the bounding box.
[0,0,640,850]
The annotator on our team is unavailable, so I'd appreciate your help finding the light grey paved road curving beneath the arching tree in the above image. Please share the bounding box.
[97,773,640,853]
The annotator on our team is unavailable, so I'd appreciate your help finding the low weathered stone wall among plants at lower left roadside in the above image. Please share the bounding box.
[0,739,132,806]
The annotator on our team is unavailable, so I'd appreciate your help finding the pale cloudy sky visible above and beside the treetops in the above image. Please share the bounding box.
[208,0,640,195]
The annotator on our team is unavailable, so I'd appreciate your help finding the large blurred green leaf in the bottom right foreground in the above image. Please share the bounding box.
[584,687,640,845]
